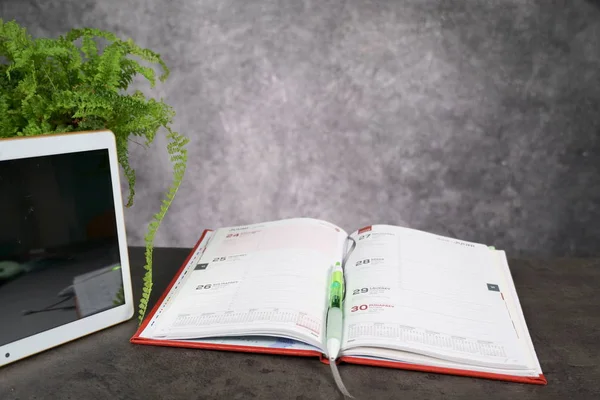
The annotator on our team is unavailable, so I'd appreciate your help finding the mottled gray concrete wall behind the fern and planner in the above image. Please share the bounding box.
[0,0,600,256]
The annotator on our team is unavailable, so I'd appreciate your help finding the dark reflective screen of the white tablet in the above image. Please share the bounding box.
[0,150,124,346]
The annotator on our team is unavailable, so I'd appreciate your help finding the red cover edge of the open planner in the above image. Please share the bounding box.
[130,229,548,385]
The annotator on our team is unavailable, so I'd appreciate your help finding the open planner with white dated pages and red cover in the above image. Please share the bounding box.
[131,218,546,384]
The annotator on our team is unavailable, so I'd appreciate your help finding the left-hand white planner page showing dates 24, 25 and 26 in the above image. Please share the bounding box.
[153,218,347,347]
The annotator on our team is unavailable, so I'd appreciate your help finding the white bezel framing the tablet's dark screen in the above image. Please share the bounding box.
[0,131,134,367]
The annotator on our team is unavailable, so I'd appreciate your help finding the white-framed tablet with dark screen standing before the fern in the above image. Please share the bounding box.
[0,131,134,366]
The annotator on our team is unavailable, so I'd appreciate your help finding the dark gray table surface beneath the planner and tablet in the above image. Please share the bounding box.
[0,248,600,400]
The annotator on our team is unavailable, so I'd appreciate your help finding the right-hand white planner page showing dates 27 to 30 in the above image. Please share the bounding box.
[343,225,528,369]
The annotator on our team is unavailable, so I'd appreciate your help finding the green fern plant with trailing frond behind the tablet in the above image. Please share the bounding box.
[0,19,188,323]
